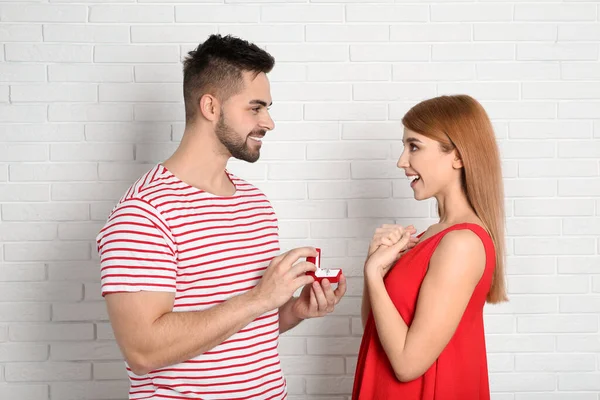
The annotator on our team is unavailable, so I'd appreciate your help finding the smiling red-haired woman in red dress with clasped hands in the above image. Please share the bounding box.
[352,95,507,400]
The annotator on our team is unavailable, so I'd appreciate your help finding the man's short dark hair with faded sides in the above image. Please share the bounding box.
[183,34,275,122]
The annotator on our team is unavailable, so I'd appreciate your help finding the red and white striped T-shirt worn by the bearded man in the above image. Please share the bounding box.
[97,164,287,399]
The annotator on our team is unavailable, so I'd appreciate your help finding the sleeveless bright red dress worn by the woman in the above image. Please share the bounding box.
[352,223,496,400]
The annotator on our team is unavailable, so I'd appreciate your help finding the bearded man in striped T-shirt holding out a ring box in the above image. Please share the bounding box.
[97,35,346,399]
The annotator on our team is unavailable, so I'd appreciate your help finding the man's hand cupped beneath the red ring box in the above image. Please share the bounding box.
[292,274,346,319]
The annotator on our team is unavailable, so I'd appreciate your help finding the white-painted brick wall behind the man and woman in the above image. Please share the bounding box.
[0,0,600,400]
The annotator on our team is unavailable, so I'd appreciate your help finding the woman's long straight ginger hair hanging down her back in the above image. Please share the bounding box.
[402,95,507,303]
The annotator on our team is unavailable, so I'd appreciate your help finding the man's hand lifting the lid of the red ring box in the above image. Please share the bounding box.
[252,247,317,311]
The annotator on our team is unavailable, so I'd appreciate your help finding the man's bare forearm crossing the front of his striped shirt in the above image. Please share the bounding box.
[116,291,268,375]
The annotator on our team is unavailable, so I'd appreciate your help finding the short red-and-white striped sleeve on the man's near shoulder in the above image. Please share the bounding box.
[96,199,177,296]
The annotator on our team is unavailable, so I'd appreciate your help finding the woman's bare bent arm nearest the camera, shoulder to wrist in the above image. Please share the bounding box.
[366,230,486,382]
